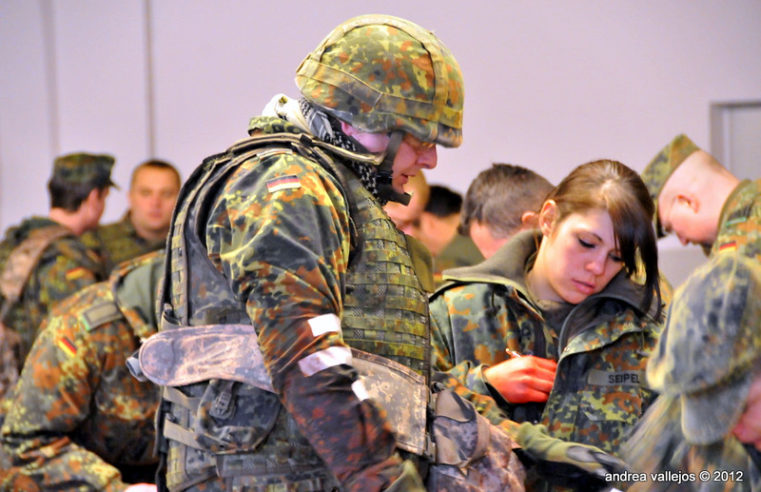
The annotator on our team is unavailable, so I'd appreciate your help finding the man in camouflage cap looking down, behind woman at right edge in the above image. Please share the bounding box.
[642,135,761,260]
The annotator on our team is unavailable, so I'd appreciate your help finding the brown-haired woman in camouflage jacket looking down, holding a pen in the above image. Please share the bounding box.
[431,161,660,488]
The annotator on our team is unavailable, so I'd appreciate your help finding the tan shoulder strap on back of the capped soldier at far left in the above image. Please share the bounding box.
[0,225,73,319]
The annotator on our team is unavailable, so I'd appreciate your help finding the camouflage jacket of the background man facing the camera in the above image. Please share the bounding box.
[80,212,166,272]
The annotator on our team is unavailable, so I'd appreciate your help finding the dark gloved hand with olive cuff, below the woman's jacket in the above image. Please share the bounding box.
[515,423,628,491]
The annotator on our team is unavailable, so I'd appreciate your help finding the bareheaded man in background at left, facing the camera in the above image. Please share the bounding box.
[82,159,181,272]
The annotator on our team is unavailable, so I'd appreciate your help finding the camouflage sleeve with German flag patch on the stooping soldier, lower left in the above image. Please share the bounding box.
[2,300,126,491]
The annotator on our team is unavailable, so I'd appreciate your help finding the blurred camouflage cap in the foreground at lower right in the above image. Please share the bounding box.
[647,253,761,444]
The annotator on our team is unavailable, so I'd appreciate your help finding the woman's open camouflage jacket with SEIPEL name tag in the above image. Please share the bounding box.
[431,231,660,454]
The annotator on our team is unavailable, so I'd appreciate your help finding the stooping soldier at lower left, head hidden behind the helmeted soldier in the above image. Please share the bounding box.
[2,252,164,491]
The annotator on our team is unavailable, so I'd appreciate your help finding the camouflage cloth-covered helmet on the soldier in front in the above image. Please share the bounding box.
[296,15,465,147]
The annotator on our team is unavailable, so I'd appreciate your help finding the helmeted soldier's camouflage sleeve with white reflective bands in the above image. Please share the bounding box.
[206,153,402,490]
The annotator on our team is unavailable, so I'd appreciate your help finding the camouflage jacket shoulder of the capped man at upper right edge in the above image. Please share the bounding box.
[710,179,761,261]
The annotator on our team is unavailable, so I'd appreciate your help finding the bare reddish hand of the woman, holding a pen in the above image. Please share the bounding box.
[484,355,558,403]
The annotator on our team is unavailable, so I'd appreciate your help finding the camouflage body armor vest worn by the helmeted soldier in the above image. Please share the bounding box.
[157,135,430,491]
